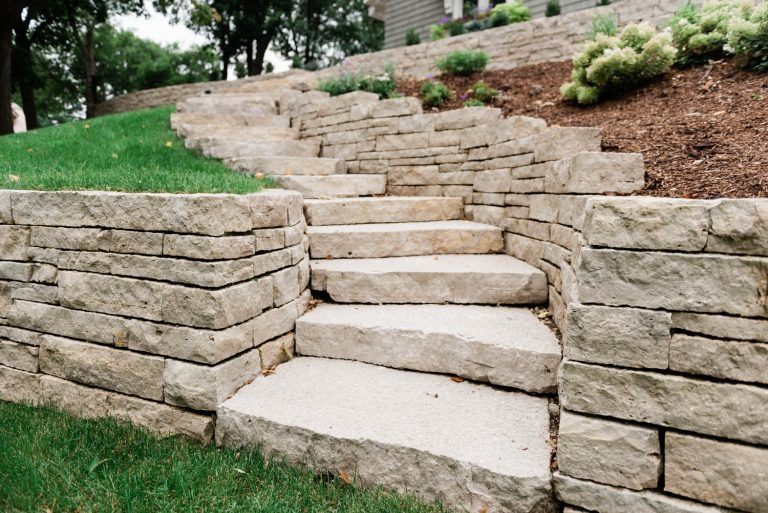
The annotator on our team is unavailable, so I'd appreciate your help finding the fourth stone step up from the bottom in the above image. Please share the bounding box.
[307,221,504,259]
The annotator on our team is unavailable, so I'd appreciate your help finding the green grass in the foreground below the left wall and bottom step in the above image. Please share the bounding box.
[0,402,444,513]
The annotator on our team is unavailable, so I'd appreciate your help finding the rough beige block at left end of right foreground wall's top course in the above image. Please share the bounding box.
[583,197,711,251]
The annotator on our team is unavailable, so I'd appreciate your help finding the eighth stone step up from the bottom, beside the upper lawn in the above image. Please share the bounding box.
[198,138,320,159]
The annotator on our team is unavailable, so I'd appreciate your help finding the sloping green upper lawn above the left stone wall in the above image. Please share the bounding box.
[0,107,270,194]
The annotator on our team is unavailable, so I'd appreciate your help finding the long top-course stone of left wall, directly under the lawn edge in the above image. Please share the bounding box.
[11,191,258,236]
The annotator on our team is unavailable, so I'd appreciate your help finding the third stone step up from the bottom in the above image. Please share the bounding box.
[311,255,547,305]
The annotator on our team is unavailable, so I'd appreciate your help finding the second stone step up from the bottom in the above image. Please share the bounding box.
[296,303,560,393]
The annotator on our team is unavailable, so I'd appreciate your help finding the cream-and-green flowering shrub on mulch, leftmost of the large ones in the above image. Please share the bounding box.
[561,23,676,105]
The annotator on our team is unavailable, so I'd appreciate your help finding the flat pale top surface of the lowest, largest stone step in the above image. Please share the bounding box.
[217,357,550,480]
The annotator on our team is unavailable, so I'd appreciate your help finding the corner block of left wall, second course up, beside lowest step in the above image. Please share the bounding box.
[162,349,261,410]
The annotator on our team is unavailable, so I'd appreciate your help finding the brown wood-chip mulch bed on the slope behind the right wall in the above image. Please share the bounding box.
[399,61,768,198]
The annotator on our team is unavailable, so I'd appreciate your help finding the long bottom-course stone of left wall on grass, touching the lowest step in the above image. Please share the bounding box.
[41,376,213,444]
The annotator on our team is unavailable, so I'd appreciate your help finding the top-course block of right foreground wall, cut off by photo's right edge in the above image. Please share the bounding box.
[706,199,768,255]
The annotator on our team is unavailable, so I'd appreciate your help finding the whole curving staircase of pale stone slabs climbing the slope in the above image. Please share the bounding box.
[173,90,561,513]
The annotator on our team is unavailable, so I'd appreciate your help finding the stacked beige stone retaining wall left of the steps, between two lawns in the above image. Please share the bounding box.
[0,191,309,441]
